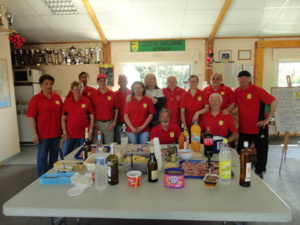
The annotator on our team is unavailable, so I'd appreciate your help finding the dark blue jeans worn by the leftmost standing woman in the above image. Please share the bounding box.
[37,137,60,177]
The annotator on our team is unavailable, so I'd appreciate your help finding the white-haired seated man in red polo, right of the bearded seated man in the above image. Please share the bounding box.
[200,93,238,142]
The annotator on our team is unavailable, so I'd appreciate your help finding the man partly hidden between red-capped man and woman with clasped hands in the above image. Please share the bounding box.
[115,75,131,144]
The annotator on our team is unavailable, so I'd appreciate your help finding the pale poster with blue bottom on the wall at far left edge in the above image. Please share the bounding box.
[0,59,10,107]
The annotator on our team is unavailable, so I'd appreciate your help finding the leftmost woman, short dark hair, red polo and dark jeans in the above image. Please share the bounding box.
[26,74,62,176]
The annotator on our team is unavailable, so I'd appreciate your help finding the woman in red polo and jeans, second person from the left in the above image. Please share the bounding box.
[61,81,95,156]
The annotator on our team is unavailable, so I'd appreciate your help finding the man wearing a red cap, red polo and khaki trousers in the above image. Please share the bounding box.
[90,74,120,144]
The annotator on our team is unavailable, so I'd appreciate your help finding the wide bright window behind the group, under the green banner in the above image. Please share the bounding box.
[123,63,192,88]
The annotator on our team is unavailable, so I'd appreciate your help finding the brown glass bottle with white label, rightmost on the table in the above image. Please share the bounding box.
[240,141,251,187]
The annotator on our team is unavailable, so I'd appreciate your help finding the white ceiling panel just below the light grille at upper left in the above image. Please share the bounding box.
[40,14,95,30]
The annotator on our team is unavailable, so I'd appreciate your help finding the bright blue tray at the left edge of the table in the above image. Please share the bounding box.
[40,173,75,184]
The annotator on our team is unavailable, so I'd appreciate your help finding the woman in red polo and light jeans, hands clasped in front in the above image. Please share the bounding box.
[124,81,155,144]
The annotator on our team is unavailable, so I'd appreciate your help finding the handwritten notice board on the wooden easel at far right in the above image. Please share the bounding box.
[271,87,300,132]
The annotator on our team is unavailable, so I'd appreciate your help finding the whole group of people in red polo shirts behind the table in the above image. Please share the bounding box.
[27,71,277,179]
